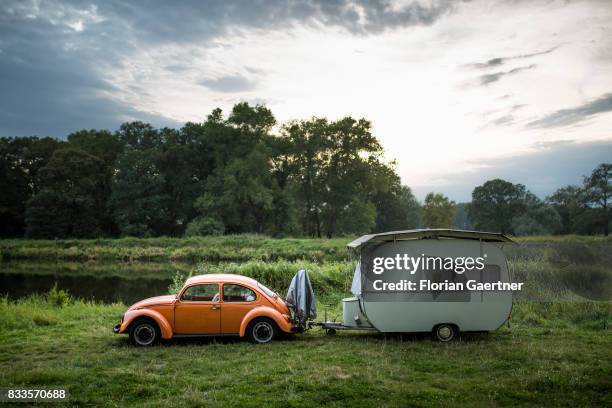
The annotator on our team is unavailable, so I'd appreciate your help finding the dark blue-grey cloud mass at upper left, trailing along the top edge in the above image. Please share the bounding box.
[0,0,455,137]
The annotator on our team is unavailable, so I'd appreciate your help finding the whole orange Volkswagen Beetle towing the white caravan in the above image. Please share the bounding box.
[113,274,297,346]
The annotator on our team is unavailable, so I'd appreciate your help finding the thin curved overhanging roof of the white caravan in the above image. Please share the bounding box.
[347,228,514,251]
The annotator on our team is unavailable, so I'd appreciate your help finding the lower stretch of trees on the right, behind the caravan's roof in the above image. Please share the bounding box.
[414,163,612,236]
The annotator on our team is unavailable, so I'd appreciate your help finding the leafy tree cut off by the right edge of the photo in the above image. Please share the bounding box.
[584,163,612,236]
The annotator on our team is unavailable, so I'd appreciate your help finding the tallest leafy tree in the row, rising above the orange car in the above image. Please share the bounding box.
[189,102,284,234]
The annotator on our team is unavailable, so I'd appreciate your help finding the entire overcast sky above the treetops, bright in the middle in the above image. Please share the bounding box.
[0,0,612,201]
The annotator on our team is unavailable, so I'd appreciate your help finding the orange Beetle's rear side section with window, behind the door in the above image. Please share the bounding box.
[221,283,260,334]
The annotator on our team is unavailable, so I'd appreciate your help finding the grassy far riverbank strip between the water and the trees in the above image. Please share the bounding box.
[0,234,612,263]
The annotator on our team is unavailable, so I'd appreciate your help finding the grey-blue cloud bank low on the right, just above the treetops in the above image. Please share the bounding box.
[413,140,612,202]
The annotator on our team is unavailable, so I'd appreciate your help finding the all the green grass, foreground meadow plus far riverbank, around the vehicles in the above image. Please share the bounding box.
[0,236,612,407]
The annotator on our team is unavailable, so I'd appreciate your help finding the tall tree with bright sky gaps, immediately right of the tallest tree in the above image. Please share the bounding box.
[282,117,382,237]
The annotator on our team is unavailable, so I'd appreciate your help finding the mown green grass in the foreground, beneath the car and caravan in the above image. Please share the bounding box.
[0,298,612,407]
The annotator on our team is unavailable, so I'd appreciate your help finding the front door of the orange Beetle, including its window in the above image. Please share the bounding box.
[174,283,221,334]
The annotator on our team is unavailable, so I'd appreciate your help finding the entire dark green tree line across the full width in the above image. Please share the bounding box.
[0,102,612,238]
